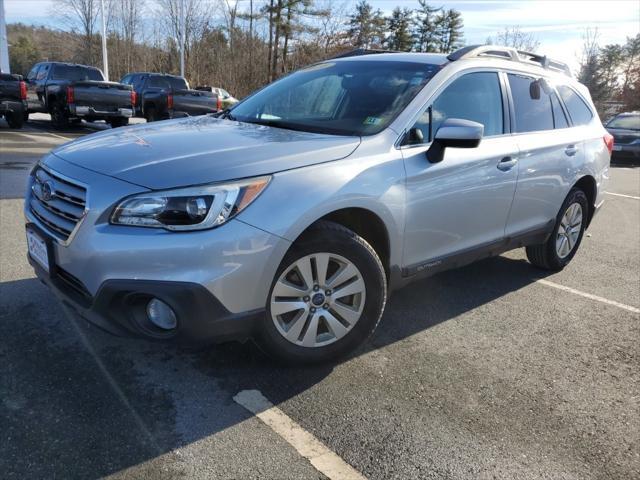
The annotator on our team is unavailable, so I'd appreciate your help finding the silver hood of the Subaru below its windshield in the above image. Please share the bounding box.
[53,116,360,189]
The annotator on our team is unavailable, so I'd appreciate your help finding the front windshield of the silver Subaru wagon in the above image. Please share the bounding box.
[232,60,439,135]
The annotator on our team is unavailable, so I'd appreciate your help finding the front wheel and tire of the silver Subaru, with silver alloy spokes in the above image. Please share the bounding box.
[256,221,387,365]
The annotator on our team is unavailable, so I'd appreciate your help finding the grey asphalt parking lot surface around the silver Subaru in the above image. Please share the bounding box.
[0,119,640,479]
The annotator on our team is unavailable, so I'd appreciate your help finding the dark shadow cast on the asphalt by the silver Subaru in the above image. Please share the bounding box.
[0,253,542,478]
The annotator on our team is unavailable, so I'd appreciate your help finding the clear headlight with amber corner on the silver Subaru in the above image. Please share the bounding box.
[111,177,271,230]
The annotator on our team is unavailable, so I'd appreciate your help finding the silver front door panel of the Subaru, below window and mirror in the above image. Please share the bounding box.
[402,136,519,267]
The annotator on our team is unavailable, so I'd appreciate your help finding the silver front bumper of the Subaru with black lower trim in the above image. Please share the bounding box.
[24,155,290,343]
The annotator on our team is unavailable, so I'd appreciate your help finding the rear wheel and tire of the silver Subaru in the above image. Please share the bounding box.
[526,188,589,272]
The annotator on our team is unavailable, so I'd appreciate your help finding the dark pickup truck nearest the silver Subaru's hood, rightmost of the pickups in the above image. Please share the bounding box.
[120,73,222,122]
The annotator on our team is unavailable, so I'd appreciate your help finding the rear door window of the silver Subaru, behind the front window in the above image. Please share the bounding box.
[508,73,553,133]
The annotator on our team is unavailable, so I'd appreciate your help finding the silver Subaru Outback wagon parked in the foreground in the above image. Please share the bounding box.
[24,46,613,363]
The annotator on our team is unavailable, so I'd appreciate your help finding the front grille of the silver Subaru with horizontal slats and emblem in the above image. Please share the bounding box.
[29,167,87,242]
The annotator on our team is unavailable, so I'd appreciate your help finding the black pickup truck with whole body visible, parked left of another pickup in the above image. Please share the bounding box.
[27,62,135,128]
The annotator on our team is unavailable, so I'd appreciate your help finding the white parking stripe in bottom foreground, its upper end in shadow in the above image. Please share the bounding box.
[233,390,366,480]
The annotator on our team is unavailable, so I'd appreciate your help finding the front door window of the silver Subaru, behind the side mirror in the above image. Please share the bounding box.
[409,72,504,143]
